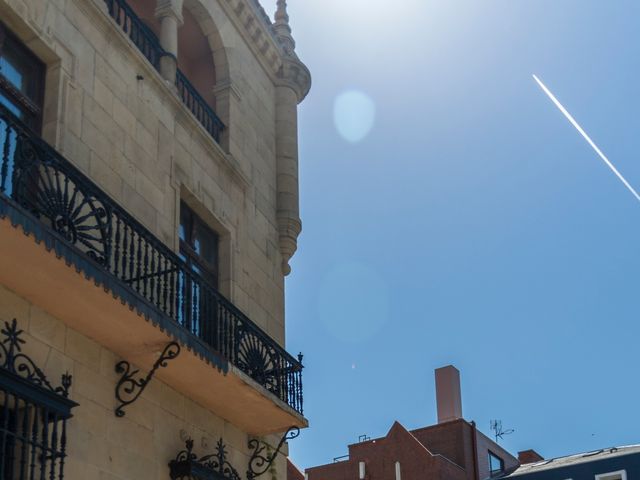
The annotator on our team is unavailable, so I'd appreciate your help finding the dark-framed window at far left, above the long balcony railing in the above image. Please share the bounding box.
[0,23,45,132]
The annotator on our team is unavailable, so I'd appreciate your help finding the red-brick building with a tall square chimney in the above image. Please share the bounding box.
[305,366,519,480]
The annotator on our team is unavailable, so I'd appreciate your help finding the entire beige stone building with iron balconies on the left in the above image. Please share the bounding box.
[0,0,311,480]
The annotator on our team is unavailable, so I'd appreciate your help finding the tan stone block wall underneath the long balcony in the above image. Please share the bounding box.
[0,287,286,480]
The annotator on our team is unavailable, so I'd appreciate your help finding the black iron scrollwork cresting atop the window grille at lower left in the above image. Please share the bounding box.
[0,318,71,398]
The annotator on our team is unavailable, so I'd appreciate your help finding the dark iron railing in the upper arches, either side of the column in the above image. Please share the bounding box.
[104,0,225,142]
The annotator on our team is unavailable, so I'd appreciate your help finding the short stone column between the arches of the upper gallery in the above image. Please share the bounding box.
[155,0,184,85]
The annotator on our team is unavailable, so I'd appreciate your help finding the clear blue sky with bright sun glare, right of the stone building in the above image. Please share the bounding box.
[287,0,640,467]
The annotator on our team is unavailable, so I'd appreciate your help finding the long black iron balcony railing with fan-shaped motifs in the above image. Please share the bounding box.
[0,105,302,413]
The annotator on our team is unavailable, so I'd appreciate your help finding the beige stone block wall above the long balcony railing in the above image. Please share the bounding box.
[0,0,284,344]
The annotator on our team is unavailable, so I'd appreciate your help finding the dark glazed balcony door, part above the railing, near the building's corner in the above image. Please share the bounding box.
[179,202,218,288]
